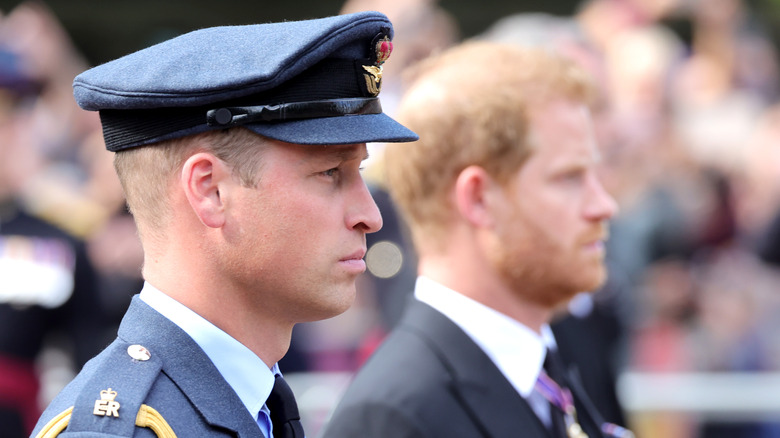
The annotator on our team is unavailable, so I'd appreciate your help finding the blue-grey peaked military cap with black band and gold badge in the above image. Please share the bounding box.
[73,12,417,151]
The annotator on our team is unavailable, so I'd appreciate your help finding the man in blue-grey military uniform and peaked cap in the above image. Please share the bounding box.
[34,12,417,438]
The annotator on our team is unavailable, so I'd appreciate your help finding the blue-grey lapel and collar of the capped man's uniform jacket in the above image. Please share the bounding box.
[119,296,262,438]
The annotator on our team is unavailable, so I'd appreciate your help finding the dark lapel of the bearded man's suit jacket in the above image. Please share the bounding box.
[400,300,550,438]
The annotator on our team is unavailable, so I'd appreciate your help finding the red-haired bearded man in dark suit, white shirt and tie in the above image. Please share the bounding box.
[323,42,630,438]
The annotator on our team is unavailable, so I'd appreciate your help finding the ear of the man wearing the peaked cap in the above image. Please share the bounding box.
[181,152,230,228]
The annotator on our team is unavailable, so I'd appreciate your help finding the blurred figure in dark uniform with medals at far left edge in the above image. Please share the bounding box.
[0,47,105,438]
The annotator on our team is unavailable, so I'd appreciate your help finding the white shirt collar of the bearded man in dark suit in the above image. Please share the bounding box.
[414,276,555,397]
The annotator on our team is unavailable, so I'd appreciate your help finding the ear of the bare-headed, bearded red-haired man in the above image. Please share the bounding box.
[455,166,496,228]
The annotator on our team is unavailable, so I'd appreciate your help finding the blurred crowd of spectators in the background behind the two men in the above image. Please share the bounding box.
[0,0,780,438]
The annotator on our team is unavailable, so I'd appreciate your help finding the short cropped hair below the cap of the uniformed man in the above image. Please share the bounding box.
[114,128,267,240]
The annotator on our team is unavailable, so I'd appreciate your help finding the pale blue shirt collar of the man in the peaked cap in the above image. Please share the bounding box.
[140,282,281,419]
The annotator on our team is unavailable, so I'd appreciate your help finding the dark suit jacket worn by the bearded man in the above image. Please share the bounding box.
[322,300,603,438]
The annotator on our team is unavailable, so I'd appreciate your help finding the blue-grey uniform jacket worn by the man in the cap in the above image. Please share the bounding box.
[32,296,263,438]
